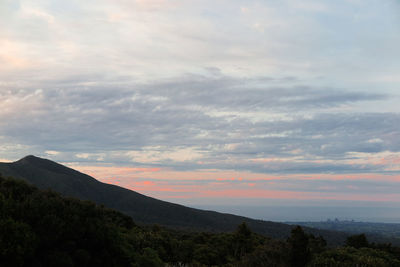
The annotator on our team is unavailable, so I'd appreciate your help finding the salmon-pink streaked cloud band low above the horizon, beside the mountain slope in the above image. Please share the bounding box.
[66,163,400,201]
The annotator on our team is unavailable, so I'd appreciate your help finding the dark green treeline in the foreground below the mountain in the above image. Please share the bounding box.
[0,175,400,267]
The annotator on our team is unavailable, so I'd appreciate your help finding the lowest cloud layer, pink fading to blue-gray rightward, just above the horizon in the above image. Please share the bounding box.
[69,166,400,201]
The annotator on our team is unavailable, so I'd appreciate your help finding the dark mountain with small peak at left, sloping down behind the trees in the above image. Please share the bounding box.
[0,156,347,244]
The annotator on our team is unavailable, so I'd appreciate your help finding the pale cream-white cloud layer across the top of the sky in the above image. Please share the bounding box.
[0,0,400,84]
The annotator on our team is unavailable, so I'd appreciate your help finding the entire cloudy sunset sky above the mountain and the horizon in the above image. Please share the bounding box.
[0,0,400,214]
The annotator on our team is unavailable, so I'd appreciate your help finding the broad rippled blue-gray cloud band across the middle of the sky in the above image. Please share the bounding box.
[0,74,400,176]
